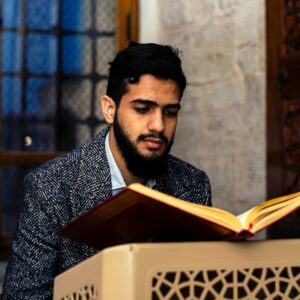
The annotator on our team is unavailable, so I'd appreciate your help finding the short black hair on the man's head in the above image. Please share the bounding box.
[106,42,186,106]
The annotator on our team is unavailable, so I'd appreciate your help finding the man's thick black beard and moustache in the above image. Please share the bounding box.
[113,113,173,178]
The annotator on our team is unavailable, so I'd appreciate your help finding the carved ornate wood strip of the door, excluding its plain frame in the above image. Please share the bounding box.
[281,0,300,194]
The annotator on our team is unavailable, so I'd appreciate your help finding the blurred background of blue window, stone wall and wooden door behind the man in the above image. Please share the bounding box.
[0,0,300,290]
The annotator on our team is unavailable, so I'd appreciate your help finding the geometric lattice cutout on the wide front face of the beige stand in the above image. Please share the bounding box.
[150,266,300,300]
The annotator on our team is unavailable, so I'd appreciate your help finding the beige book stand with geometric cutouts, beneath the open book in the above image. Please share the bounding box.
[54,239,300,300]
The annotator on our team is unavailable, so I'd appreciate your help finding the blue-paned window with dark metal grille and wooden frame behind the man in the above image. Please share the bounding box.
[0,0,137,245]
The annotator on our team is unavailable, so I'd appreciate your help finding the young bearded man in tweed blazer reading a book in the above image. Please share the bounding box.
[3,43,211,299]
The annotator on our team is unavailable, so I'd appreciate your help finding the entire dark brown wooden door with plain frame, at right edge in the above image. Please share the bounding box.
[266,0,300,238]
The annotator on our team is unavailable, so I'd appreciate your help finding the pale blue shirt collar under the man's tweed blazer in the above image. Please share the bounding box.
[105,133,156,195]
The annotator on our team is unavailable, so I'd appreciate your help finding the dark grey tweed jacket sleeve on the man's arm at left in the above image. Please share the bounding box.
[2,175,59,300]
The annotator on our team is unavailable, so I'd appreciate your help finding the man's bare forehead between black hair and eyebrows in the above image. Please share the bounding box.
[122,74,180,104]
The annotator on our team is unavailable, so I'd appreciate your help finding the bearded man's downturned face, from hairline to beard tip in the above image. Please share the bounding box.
[113,75,180,176]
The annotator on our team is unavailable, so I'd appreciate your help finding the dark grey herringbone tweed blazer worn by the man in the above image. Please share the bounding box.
[2,128,211,300]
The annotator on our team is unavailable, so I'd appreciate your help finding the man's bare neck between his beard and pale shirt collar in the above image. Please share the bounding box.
[109,130,146,185]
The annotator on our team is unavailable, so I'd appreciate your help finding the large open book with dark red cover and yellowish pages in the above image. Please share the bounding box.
[58,184,300,249]
